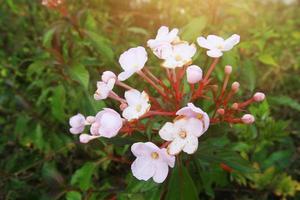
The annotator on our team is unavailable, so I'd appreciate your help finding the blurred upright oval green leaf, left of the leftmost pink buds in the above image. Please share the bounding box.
[51,85,66,122]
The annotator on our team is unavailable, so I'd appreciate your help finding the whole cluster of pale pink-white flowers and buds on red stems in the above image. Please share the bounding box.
[69,26,265,183]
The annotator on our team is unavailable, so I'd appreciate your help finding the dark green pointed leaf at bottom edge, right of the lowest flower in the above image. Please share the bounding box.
[166,164,198,200]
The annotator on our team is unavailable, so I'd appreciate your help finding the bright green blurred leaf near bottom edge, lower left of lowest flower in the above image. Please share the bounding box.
[71,162,96,191]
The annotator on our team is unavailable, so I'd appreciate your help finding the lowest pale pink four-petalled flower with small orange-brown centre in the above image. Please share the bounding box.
[131,142,175,183]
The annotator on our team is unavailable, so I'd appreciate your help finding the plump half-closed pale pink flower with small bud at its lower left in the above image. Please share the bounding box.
[79,108,123,143]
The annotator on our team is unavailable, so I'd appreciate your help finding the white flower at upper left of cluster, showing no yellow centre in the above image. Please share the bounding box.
[118,46,148,81]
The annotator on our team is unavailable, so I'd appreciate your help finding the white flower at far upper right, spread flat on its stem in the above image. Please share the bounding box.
[197,34,240,58]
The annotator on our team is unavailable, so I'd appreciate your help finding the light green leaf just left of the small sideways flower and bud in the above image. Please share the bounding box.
[70,63,90,89]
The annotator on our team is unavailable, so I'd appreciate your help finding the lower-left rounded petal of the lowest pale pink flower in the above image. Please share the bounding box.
[131,157,155,181]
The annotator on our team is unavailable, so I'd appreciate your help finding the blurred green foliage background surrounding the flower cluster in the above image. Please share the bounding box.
[0,0,300,200]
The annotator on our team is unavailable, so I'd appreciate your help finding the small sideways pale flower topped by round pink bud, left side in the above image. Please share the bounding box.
[94,71,117,100]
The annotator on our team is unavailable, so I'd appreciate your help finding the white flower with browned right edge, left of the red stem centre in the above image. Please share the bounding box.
[122,89,151,121]
